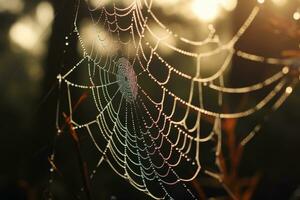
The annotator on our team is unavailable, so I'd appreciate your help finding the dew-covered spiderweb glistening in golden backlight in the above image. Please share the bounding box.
[52,0,297,199]
